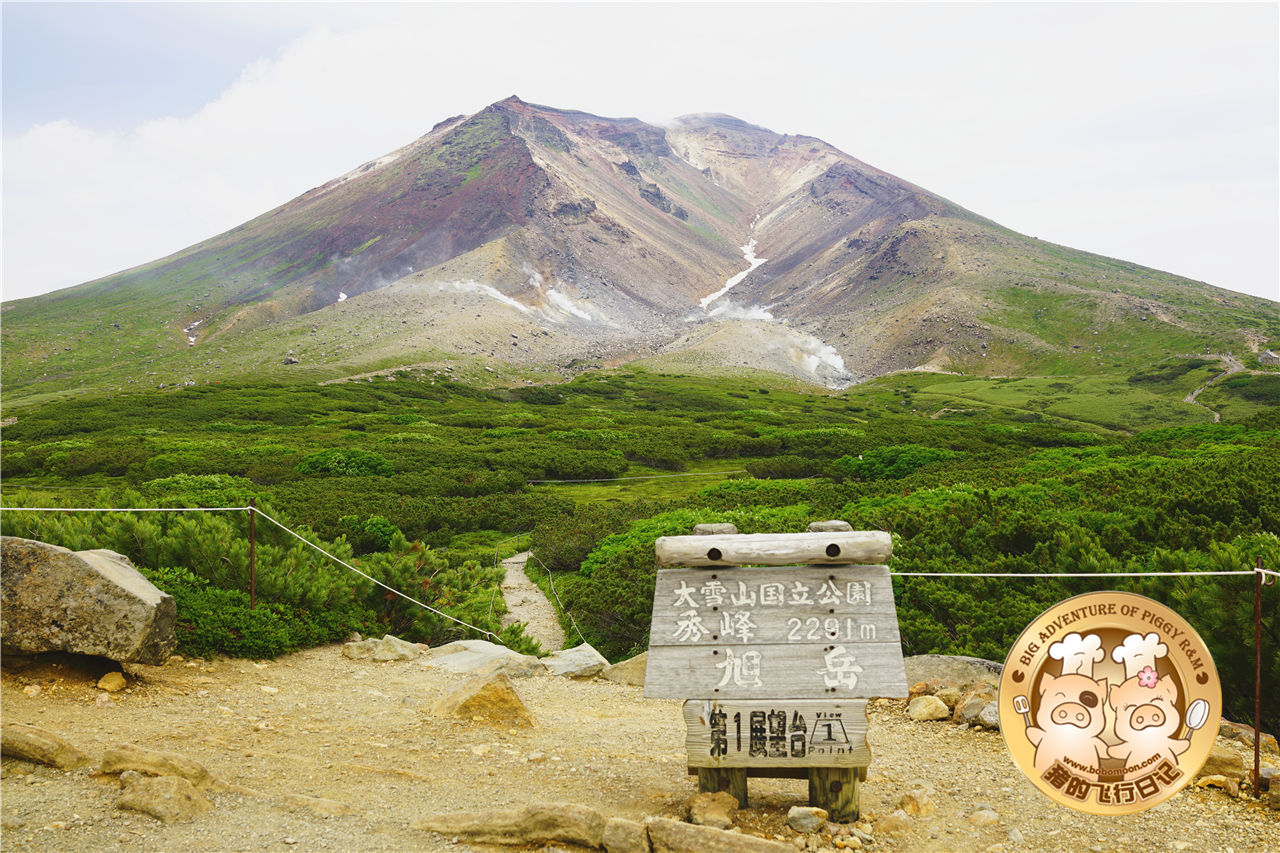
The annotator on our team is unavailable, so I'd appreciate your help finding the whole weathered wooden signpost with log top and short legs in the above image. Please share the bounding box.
[645,521,908,821]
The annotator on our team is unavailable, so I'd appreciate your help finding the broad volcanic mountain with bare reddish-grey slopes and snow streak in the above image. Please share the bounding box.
[3,97,1280,397]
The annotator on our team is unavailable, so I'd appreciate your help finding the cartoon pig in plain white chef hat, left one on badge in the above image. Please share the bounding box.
[1027,633,1107,781]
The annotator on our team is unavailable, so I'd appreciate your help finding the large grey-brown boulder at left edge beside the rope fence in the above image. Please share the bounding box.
[0,537,178,665]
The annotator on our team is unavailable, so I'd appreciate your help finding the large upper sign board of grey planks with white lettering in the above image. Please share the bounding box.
[644,563,908,701]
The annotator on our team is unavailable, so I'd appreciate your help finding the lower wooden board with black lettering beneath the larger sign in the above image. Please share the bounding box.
[685,699,872,770]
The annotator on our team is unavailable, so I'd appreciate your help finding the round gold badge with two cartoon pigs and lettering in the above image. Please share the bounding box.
[1000,592,1222,815]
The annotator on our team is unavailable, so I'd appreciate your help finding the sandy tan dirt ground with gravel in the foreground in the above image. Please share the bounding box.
[0,646,1280,853]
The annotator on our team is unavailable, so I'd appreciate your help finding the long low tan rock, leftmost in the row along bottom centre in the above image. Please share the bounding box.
[411,803,604,848]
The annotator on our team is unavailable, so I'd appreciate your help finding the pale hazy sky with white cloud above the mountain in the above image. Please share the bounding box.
[3,3,1280,300]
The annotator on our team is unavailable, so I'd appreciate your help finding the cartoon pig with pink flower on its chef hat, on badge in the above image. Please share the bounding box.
[1107,633,1192,767]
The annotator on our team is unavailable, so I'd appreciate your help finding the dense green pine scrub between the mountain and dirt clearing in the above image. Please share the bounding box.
[0,368,1280,729]
